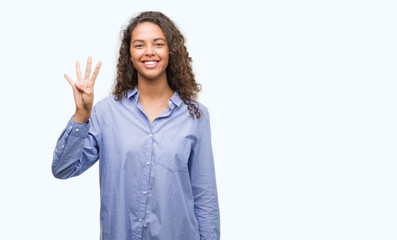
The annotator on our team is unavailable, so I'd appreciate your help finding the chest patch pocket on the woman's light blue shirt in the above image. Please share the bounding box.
[156,138,191,172]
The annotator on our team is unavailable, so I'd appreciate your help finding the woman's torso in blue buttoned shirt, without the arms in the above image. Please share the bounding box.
[92,92,208,240]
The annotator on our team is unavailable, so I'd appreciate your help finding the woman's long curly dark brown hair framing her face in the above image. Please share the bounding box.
[112,11,201,119]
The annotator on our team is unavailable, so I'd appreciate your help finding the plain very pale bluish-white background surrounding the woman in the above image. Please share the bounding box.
[0,0,397,240]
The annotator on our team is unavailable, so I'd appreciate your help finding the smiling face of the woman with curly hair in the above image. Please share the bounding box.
[130,22,169,80]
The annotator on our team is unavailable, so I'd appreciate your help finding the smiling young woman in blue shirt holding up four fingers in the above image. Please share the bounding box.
[52,12,220,240]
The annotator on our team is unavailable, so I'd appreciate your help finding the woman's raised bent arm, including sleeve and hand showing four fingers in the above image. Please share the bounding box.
[52,57,102,179]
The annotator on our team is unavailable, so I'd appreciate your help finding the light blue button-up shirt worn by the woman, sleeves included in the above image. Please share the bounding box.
[52,88,220,240]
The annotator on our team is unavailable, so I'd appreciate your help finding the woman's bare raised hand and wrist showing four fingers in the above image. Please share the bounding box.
[64,57,102,123]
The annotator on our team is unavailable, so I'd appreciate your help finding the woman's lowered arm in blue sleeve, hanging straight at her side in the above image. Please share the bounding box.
[189,115,220,240]
